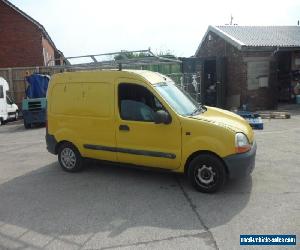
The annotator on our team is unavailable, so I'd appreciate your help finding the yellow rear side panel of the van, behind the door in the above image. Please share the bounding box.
[48,72,116,161]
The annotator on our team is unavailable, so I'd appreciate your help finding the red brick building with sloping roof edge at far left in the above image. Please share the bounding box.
[0,0,63,68]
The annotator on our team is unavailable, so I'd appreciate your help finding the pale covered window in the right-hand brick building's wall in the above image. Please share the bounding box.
[247,61,270,90]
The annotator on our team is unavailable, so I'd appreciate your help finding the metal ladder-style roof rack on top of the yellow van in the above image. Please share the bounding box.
[47,48,182,70]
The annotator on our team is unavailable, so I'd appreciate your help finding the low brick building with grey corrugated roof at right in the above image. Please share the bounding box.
[194,25,300,109]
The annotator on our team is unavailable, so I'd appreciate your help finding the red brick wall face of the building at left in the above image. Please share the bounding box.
[0,1,44,68]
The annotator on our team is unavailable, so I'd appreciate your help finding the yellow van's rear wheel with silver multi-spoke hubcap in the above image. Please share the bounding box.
[58,142,83,172]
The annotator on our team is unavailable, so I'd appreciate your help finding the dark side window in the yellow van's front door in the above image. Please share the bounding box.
[118,83,163,122]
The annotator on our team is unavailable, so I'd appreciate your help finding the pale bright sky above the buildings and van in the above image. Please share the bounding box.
[10,0,300,57]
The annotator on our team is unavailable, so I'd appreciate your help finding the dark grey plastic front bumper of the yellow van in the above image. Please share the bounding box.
[223,142,257,179]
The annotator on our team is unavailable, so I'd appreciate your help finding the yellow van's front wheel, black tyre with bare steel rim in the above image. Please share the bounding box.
[187,154,226,193]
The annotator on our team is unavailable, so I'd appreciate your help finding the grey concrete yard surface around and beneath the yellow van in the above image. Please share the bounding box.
[0,114,300,249]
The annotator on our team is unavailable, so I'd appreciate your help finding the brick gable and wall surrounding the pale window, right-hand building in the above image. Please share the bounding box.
[196,32,277,109]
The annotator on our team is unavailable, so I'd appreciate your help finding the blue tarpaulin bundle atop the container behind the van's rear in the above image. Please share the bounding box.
[26,74,50,98]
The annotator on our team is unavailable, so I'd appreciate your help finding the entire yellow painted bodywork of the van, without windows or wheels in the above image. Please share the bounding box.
[47,70,254,172]
